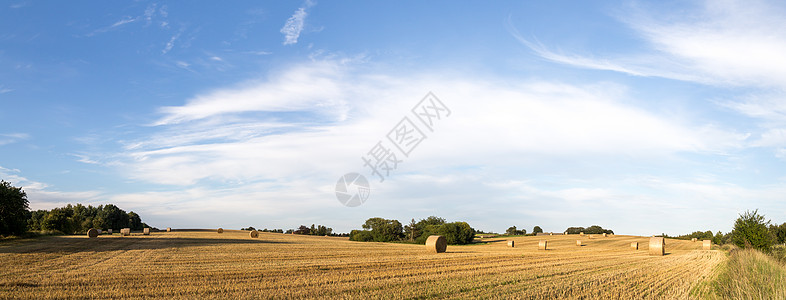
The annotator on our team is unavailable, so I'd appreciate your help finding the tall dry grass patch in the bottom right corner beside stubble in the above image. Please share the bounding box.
[693,247,786,299]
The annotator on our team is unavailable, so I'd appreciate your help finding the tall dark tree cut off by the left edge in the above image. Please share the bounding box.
[0,180,30,235]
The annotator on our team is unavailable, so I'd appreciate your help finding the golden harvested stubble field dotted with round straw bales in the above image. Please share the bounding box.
[0,230,727,299]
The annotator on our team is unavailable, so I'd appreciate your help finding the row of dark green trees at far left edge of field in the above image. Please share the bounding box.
[0,181,150,236]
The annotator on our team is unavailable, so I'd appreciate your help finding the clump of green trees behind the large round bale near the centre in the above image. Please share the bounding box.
[349,216,476,245]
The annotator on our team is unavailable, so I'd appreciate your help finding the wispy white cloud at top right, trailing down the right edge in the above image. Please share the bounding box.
[509,1,786,161]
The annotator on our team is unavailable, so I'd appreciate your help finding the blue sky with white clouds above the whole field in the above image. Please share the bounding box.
[0,1,786,235]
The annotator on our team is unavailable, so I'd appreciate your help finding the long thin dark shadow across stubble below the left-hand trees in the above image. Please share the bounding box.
[0,236,291,253]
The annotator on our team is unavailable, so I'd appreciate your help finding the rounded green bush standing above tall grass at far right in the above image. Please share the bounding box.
[731,209,773,253]
